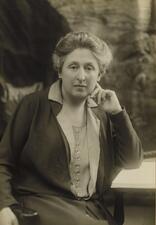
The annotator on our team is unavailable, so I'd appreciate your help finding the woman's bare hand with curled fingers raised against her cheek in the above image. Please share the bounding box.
[90,83,122,114]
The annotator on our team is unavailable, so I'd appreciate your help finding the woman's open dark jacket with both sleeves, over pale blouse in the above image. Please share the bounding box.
[0,87,142,208]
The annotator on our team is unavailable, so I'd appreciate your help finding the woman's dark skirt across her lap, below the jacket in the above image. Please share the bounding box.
[16,195,108,225]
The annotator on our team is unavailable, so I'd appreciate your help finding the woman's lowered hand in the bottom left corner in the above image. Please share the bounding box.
[0,207,19,225]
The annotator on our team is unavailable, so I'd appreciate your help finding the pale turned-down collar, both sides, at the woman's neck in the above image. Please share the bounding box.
[48,80,98,108]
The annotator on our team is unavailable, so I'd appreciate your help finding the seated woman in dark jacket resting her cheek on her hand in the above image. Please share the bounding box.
[0,32,142,225]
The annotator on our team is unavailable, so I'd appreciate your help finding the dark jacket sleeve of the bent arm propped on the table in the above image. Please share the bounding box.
[110,109,143,169]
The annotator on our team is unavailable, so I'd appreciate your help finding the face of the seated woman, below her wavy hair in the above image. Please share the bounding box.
[59,48,100,103]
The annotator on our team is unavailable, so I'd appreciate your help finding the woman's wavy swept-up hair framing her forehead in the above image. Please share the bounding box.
[52,32,112,75]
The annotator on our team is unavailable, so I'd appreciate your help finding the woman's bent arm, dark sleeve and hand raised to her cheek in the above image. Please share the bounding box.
[91,84,143,168]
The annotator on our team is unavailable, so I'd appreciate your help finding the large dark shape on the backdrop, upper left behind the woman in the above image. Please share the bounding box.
[0,0,70,86]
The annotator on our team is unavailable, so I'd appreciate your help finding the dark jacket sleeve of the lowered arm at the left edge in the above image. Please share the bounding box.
[0,94,33,209]
